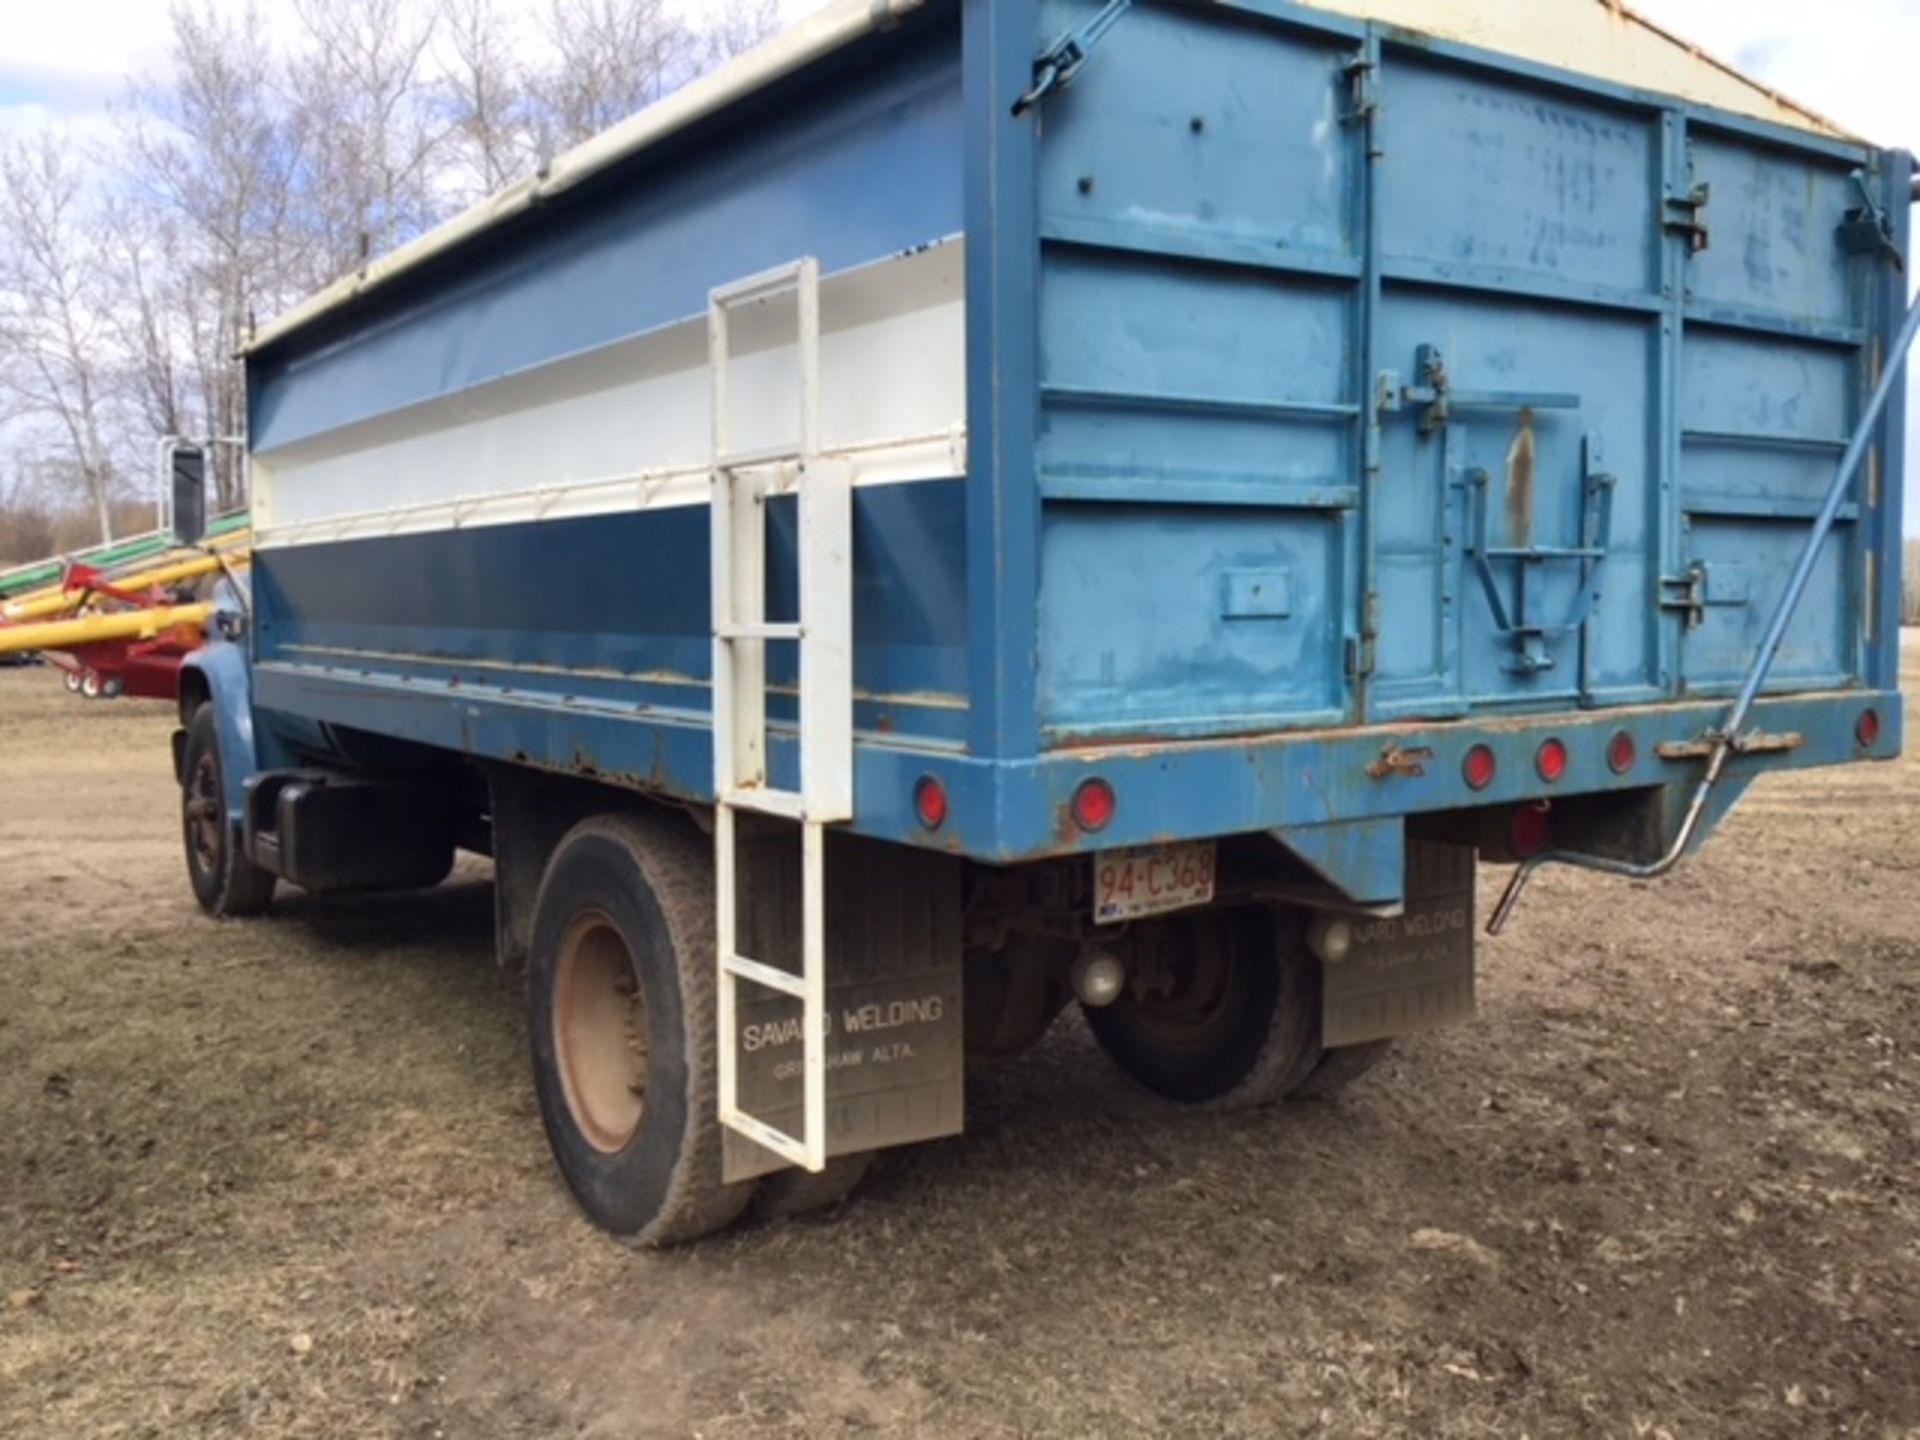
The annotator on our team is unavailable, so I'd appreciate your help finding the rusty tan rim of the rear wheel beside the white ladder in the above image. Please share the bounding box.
[553,910,647,1154]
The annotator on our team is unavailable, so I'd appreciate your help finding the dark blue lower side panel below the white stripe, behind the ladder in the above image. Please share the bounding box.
[253,480,966,739]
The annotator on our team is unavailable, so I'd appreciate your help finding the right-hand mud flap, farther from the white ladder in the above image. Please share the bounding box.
[1321,839,1475,1048]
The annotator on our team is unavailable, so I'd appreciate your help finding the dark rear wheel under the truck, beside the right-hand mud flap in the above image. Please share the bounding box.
[1085,910,1321,1110]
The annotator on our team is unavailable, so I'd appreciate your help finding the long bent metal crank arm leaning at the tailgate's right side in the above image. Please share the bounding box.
[1486,284,1920,935]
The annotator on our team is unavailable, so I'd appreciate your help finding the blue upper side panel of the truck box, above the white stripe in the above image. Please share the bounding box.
[252,33,962,451]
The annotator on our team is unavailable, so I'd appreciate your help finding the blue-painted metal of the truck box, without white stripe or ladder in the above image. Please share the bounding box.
[240,0,1912,879]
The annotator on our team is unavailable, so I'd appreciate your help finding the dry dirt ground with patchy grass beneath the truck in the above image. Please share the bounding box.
[0,647,1920,1440]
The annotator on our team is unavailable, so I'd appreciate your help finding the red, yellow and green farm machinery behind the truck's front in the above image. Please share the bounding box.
[0,442,253,699]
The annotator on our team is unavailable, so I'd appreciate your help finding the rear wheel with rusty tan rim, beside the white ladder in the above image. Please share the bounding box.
[528,814,755,1246]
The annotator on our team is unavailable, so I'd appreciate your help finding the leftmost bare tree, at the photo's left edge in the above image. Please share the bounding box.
[0,131,117,541]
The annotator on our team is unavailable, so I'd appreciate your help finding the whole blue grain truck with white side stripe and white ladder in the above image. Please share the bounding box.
[177,0,1912,1244]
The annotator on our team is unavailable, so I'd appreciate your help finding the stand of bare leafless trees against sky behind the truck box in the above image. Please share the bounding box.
[0,0,778,534]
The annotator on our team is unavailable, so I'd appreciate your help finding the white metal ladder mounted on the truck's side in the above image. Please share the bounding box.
[707,257,852,1171]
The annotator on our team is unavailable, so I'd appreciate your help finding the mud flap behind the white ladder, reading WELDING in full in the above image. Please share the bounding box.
[722,829,966,1181]
